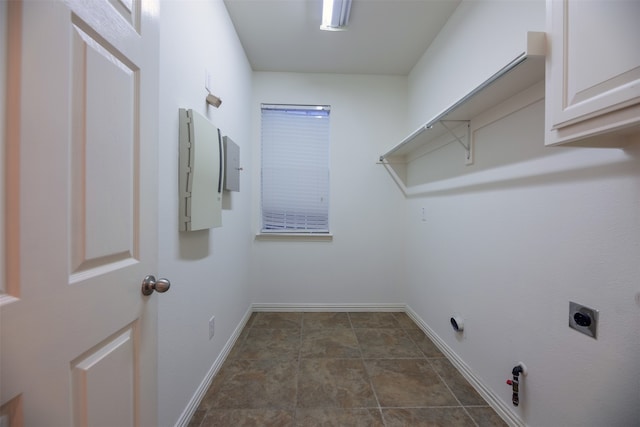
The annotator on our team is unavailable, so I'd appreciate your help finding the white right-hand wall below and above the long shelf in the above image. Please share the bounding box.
[405,2,640,427]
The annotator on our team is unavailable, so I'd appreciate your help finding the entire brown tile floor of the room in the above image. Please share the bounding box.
[189,312,506,427]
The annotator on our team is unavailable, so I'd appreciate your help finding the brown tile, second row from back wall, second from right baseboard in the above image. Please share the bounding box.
[354,329,424,359]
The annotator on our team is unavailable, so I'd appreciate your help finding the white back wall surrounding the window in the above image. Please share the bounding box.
[251,73,406,306]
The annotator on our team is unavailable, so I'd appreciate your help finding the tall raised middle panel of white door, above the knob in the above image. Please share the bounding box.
[71,19,139,282]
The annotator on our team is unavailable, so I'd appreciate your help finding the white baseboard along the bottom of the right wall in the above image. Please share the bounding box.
[406,306,526,427]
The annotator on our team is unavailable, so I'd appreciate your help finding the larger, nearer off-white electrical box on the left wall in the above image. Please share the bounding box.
[178,108,224,231]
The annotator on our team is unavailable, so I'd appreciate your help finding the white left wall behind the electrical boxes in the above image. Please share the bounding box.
[154,0,252,426]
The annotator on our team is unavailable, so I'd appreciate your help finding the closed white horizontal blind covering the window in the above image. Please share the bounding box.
[262,104,330,233]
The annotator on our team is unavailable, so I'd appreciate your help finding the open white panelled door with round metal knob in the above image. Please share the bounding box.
[0,0,160,427]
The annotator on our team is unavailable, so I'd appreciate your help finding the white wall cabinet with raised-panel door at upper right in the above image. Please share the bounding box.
[545,0,640,145]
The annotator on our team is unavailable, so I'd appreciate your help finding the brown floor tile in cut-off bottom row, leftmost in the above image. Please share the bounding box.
[201,409,294,427]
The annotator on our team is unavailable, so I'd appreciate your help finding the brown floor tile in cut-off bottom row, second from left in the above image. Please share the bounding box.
[296,408,384,427]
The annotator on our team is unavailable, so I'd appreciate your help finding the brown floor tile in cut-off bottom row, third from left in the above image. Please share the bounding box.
[382,408,475,427]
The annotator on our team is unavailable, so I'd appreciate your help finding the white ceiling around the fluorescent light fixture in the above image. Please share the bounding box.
[224,0,460,75]
